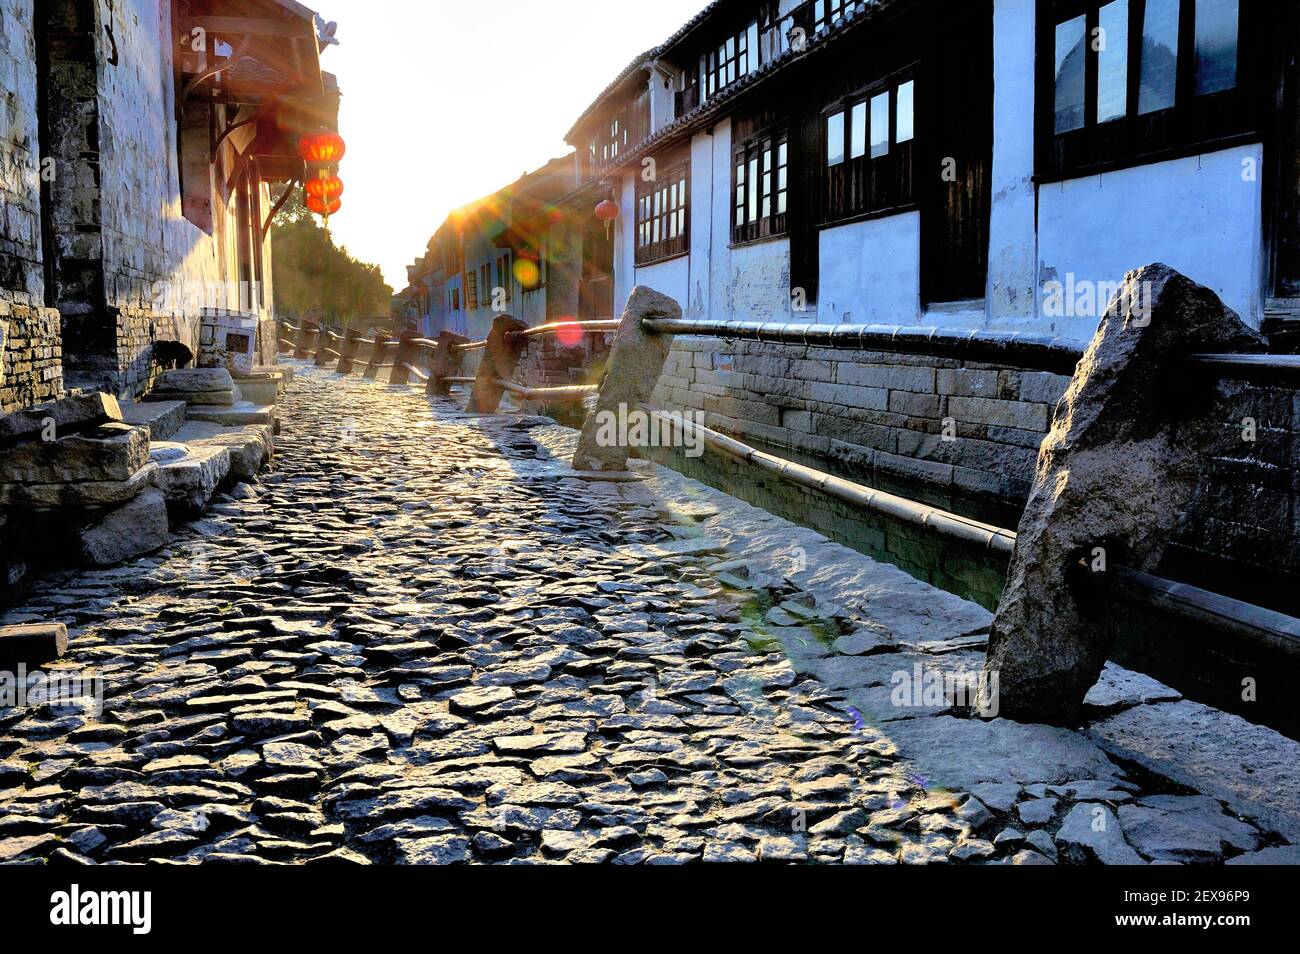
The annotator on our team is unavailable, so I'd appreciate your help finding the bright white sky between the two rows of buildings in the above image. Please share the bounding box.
[321,0,707,291]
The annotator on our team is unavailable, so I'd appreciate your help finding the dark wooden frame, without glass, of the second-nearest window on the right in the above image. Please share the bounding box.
[819,65,920,225]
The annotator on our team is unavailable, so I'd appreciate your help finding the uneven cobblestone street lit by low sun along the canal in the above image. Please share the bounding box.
[0,365,1284,863]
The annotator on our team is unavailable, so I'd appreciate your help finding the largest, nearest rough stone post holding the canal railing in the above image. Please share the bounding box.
[982,265,1265,724]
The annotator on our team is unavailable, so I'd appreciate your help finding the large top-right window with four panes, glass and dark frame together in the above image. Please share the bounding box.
[1039,0,1262,177]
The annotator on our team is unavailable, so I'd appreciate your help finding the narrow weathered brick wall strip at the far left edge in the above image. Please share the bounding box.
[0,0,62,413]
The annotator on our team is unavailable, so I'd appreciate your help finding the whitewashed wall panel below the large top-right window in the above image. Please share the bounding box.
[1037,144,1264,338]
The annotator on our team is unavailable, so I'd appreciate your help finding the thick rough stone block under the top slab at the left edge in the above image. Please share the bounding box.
[0,422,150,483]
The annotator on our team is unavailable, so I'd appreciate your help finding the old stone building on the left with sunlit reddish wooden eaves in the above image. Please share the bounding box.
[0,0,338,411]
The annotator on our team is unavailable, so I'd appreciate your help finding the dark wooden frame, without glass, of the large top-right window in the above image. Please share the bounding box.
[1035,0,1269,182]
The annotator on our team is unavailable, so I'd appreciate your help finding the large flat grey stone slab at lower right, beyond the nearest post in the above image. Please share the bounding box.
[1079,699,1300,844]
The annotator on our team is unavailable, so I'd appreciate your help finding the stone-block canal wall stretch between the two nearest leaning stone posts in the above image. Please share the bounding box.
[655,338,1069,504]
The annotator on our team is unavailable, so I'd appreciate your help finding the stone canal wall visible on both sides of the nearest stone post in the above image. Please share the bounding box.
[654,338,1300,613]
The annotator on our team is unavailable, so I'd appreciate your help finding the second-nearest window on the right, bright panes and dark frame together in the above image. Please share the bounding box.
[824,75,917,221]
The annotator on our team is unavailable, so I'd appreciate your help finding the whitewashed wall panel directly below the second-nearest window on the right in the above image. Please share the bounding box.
[818,212,920,325]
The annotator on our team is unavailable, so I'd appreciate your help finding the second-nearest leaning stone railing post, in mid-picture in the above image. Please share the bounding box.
[573,285,681,471]
